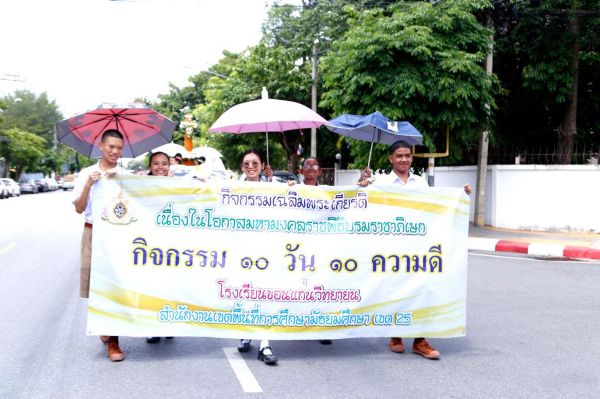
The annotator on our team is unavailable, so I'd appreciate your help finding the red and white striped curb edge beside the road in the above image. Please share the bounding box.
[469,237,600,259]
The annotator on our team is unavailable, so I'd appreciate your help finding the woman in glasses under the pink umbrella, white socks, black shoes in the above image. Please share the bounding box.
[238,149,277,364]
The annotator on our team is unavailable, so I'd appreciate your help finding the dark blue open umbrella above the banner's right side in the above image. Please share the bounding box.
[325,111,423,167]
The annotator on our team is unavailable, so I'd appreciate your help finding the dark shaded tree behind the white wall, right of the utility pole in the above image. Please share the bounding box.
[494,0,600,163]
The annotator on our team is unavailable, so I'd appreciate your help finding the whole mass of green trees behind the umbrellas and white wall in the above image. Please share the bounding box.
[148,0,600,170]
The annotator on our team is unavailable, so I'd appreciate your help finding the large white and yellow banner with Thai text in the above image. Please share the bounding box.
[87,176,469,339]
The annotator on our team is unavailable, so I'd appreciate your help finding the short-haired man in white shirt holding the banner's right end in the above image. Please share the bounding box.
[358,140,471,359]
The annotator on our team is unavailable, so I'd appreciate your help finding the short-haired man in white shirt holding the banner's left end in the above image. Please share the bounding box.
[73,129,125,362]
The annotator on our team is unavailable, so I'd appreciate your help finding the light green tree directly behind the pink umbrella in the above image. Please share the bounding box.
[158,0,396,171]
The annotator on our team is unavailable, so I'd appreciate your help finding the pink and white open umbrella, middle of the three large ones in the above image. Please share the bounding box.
[208,87,327,164]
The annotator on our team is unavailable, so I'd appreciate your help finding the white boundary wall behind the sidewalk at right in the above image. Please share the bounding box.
[435,165,600,233]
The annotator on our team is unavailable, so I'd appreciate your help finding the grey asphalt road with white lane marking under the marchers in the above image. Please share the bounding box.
[0,192,600,399]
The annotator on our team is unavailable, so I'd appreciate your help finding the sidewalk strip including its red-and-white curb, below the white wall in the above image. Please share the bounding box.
[469,224,600,260]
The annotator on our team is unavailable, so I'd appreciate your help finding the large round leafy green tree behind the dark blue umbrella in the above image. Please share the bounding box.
[322,0,496,168]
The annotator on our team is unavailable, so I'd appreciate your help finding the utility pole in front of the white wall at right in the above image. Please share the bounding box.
[474,14,494,226]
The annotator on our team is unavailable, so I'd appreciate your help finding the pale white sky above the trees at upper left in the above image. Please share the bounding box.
[0,0,299,118]
